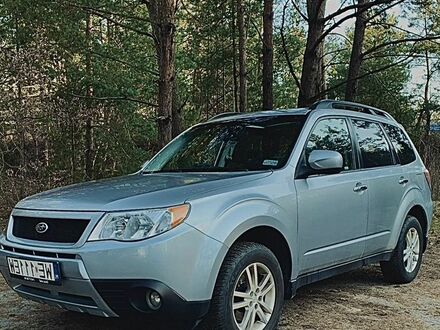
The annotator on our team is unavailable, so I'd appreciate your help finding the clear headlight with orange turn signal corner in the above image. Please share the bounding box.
[89,204,189,241]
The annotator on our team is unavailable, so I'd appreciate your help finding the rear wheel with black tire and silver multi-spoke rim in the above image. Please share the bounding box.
[380,215,424,284]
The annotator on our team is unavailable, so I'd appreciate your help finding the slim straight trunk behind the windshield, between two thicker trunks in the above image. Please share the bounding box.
[237,0,247,112]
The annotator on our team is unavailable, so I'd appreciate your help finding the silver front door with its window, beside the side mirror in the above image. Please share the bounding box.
[295,118,368,273]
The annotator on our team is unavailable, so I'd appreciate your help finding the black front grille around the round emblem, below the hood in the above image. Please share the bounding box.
[12,216,90,244]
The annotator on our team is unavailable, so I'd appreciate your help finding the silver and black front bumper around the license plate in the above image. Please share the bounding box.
[0,224,227,319]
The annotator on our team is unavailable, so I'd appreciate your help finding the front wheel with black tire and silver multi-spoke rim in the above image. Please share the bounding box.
[198,242,284,330]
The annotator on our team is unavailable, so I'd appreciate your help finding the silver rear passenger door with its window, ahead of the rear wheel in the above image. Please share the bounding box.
[352,119,406,256]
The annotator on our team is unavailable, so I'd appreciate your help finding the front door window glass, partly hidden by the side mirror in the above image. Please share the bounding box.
[305,118,354,170]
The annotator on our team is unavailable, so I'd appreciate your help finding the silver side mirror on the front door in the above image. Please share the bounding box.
[308,150,344,174]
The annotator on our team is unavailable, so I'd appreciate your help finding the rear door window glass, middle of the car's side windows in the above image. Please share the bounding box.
[353,120,393,168]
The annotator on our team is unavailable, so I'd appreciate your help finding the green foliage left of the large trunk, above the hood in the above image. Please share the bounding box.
[0,0,157,203]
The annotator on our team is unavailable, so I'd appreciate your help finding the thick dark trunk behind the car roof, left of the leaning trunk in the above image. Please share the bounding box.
[298,0,327,107]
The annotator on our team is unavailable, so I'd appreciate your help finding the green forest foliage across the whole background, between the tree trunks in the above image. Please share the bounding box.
[0,0,440,209]
